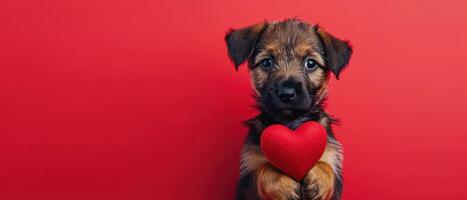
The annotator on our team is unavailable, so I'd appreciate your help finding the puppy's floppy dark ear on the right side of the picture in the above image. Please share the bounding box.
[316,27,352,79]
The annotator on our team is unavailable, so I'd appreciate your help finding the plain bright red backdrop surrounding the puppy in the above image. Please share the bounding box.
[0,0,467,200]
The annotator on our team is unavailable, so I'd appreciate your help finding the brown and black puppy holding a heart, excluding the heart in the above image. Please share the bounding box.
[225,19,352,200]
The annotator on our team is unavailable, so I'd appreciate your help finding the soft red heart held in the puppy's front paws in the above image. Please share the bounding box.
[261,122,327,181]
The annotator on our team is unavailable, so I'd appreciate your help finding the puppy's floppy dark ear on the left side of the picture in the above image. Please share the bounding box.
[225,22,266,70]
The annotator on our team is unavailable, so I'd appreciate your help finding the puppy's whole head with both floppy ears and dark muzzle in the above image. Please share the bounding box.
[225,19,352,119]
